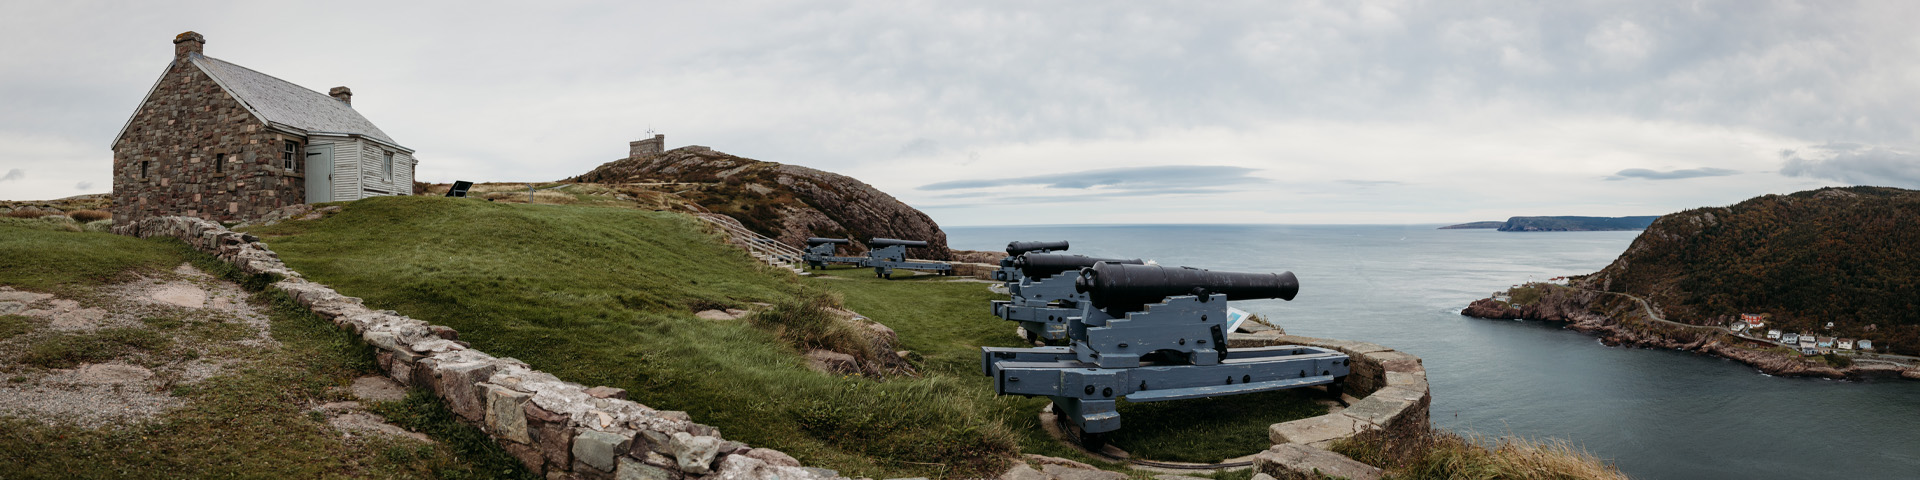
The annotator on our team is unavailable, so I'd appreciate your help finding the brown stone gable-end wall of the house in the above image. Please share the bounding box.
[113,50,305,225]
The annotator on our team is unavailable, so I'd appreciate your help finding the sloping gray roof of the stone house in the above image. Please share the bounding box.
[192,56,399,146]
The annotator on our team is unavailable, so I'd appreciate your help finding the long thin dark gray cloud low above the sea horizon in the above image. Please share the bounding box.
[920,165,1265,196]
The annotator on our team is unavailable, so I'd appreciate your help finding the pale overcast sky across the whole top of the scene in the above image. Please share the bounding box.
[0,0,1920,225]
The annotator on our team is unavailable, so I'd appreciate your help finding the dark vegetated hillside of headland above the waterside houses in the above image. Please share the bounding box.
[1578,186,1920,353]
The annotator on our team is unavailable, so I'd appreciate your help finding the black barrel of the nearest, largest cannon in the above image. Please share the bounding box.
[1073,263,1300,311]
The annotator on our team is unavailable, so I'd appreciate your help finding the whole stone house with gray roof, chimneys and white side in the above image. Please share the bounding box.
[113,33,419,225]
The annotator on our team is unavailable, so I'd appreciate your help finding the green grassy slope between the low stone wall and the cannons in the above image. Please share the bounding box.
[236,198,1317,478]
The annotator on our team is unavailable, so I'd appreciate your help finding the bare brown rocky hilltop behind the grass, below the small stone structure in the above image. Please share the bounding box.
[568,146,952,259]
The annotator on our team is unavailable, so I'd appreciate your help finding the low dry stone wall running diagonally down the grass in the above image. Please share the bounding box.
[115,217,841,480]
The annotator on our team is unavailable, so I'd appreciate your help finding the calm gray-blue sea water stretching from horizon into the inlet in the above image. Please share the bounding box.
[947,225,1920,478]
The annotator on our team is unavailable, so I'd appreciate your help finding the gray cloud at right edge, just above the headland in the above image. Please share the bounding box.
[1780,144,1920,188]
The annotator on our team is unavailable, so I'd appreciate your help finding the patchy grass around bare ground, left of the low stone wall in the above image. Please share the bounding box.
[0,225,526,478]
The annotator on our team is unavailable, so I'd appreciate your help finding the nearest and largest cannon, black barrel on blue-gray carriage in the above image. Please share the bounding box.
[981,263,1348,447]
